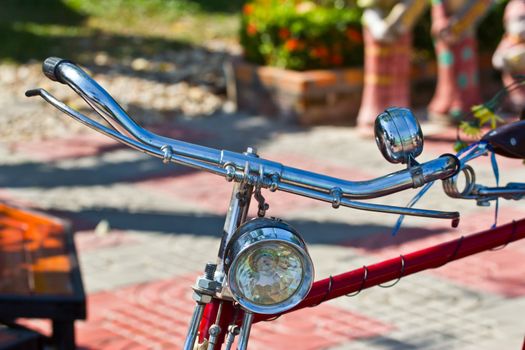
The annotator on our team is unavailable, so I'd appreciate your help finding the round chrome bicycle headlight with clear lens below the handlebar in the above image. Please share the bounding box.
[226,218,314,314]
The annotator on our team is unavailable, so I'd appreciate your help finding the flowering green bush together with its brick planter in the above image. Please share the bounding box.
[228,0,363,124]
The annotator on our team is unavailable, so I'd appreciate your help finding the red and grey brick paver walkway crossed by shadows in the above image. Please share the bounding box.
[0,115,525,349]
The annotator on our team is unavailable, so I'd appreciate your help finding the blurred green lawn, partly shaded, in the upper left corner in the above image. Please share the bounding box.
[0,0,245,63]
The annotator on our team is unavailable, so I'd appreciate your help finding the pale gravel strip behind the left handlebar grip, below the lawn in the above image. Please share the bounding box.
[0,45,232,143]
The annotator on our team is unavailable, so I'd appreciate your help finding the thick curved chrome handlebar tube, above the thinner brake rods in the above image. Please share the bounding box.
[48,62,455,199]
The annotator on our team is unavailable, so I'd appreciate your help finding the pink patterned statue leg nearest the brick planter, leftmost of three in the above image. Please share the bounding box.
[357,0,427,135]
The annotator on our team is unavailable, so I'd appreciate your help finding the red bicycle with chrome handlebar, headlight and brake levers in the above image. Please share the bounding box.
[26,58,525,350]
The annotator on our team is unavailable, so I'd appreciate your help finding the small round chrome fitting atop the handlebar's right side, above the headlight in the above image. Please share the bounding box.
[374,107,423,165]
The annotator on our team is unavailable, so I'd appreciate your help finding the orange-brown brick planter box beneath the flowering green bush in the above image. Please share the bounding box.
[226,59,363,125]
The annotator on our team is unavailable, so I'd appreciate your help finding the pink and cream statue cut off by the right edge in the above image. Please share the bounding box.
[492,0,525,118]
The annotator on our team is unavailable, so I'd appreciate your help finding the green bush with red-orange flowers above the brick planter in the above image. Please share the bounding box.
[240,0,363,70]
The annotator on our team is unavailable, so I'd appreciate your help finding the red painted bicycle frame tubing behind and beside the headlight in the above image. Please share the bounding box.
[199,219,525,349]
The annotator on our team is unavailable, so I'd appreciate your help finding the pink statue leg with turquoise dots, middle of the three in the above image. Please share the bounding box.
[428,0,492,123]
